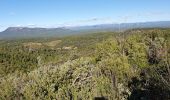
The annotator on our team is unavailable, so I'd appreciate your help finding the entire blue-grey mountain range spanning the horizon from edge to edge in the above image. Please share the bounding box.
[0,21,170,39]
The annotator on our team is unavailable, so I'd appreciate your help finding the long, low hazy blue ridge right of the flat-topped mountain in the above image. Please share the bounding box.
[70,21,170,31]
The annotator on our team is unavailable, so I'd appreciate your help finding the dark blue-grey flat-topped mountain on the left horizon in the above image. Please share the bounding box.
[0,27,74,38]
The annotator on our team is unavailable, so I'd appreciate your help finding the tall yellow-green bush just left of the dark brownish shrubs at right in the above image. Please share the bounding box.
[125,34,148,68]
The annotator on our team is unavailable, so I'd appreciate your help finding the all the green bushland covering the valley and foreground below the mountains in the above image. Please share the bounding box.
[0,29,170,100]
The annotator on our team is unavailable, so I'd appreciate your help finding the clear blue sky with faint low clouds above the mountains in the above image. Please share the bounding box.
[0,0,170,31]
